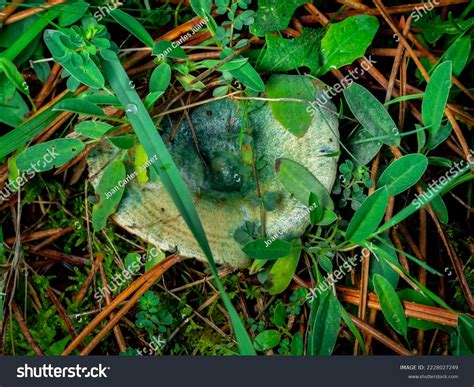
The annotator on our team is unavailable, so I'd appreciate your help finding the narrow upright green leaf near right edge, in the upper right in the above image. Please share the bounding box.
[421,62,453,136]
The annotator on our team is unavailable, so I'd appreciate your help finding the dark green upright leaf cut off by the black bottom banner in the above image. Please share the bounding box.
[308,291,341,356]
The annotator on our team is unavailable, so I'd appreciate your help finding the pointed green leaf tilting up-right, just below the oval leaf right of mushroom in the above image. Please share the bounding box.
[346,187,388,244]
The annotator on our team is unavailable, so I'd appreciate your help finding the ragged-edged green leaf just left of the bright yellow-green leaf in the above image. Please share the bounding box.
[258,28,321,72]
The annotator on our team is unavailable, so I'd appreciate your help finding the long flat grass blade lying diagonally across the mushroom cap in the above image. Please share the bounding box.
[102,56,255,355]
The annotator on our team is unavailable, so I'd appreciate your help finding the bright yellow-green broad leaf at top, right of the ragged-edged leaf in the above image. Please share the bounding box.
[318,15,379,75]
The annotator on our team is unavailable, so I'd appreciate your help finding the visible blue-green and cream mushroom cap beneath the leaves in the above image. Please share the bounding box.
[88,89,339,268]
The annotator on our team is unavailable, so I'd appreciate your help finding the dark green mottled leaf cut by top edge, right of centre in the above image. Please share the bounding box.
[250,0,308,36]
